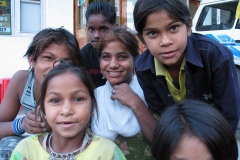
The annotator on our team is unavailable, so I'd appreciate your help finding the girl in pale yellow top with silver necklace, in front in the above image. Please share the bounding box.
[11,60,125,160]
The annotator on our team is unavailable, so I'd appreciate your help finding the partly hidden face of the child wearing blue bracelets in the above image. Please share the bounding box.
[29,43,71,85]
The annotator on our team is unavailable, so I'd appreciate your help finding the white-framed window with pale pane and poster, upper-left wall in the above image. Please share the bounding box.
[0,0,43,36]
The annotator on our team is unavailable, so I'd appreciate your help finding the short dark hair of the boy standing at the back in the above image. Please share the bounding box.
[85,2,117,25]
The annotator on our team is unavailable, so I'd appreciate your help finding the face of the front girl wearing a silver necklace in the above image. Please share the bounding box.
[44,72,92,138]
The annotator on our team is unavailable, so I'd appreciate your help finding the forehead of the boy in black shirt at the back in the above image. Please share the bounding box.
[87,14,112,27]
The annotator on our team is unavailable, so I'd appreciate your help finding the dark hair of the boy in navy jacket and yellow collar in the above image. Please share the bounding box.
[133,0,192,36]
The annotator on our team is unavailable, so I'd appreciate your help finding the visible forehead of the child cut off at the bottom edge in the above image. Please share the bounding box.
[170,135,213,160]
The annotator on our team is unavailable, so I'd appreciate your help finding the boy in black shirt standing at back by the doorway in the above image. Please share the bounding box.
[81,2,117,87]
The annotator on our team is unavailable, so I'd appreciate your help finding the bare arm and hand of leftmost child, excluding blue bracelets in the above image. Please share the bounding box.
[0,71,49,139]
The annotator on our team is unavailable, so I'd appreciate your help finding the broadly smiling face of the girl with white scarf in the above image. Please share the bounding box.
[100,41,133,85]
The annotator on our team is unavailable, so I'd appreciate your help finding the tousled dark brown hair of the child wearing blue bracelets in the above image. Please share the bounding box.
[24,28,83,67]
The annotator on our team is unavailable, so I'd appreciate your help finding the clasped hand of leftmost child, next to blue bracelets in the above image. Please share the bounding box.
[22,107,51,134]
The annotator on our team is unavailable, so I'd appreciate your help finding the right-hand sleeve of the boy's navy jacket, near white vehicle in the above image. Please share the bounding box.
[212,47,240,132]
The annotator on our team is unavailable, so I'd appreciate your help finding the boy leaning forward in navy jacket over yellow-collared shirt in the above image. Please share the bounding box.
[134,0,240,132]
